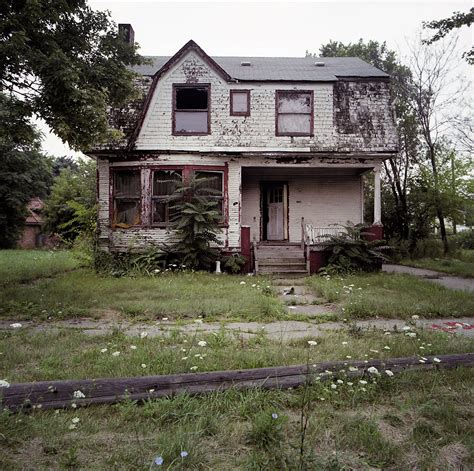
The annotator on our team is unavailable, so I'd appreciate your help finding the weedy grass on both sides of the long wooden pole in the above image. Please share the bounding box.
[0,331,474,470]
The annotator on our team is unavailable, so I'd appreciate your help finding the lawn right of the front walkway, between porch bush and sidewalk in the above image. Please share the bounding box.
[307,273,474,319]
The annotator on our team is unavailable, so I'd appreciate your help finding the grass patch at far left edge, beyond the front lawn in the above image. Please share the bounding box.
[0,250,79,286]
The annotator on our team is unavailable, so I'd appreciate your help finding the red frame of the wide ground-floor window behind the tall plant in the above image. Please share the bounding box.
[148,164,229,229]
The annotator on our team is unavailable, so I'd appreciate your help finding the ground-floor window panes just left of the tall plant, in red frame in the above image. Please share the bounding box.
[152,170,182,225]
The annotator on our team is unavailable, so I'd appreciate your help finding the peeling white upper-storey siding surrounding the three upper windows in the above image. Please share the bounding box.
[136,51,396,152]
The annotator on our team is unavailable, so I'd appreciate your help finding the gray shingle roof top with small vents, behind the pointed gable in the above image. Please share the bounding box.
[134,56,388,82]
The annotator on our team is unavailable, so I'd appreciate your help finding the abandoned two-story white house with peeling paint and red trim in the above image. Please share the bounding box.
[91,25,397,273]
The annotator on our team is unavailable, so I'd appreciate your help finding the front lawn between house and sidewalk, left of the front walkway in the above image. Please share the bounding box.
[0,269,287,320]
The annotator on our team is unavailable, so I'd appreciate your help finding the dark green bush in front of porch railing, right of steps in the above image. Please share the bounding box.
[322,222,388,274]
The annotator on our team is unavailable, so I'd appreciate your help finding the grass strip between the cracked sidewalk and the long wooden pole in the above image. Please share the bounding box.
[0,329,474,382]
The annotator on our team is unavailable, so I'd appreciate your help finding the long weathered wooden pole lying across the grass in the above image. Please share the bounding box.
[0,353,474,411]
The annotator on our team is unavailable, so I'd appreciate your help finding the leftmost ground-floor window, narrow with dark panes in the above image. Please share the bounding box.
[113,170,141,227]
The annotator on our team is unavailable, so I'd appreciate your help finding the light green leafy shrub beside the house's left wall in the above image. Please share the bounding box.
[44,160,96,242]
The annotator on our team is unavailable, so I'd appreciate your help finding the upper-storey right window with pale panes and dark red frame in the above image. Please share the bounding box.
[276,90,313,136]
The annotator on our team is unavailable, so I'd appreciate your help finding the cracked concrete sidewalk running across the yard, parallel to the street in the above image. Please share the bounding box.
[0,317,474,341]
